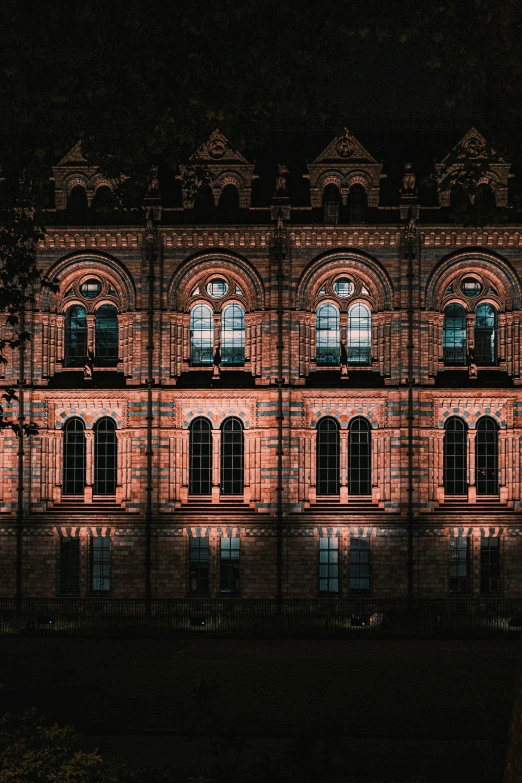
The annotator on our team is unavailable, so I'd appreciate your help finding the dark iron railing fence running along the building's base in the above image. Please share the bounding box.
[0,597,522,638]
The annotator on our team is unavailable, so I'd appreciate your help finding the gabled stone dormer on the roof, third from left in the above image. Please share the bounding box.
[308,129,383,207]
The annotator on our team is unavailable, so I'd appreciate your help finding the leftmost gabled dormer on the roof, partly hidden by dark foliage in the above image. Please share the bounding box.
[53,141,114,212]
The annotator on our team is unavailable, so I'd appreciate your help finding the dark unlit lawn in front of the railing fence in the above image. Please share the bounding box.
[0,638,521,783]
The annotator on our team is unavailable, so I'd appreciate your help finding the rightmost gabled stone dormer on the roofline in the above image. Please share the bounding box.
[435,128,513,207]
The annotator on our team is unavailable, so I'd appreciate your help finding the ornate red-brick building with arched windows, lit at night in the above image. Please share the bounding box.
[0,129,522,598]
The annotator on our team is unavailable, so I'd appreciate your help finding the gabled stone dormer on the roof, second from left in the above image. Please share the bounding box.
[180,129,255,212]
